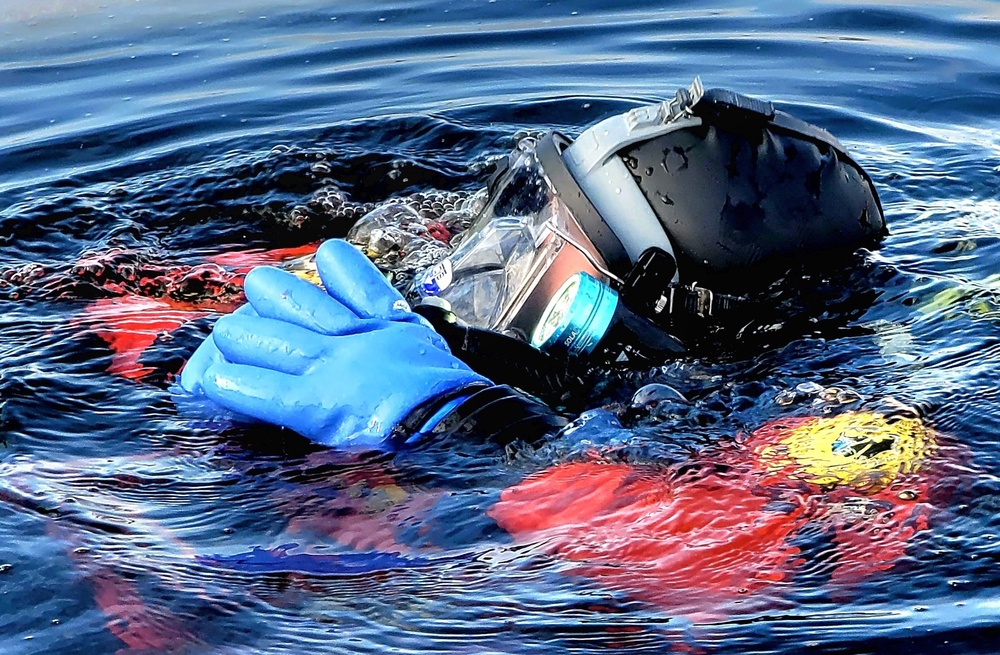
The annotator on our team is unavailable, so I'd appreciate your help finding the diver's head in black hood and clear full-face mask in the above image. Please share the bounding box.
[416,79,886,366]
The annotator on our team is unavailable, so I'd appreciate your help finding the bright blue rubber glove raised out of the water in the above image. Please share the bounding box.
[180,240,489,448]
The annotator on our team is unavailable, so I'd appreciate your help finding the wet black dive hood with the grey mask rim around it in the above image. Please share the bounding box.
[537,79,887,294]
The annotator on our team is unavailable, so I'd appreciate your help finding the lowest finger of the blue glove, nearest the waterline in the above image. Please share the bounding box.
[203,362,305,430]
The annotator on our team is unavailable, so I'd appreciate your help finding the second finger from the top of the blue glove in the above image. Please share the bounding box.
[243,266,362,335]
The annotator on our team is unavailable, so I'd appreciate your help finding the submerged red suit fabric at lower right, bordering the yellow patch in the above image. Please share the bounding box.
[489,418,948,618]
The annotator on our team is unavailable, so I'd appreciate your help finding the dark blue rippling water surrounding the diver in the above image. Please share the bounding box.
[0,0,1000,655]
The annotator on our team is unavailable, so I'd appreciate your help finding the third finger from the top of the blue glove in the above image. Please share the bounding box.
[212,316,325,375]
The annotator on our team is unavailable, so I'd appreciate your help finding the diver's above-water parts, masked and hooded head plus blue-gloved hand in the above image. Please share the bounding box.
[180,79,886,449]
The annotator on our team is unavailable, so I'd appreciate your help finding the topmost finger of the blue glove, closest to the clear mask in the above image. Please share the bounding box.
[316,239,421,323]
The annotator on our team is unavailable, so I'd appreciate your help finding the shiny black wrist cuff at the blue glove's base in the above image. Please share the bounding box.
[392,383,567,444]
